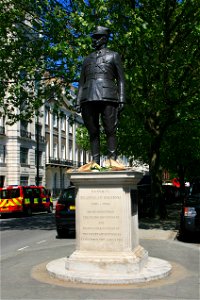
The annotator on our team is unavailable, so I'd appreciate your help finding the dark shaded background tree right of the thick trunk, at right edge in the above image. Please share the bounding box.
[161,120,200,201]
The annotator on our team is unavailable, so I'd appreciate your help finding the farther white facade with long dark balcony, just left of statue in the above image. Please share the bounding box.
[45,97,90,195]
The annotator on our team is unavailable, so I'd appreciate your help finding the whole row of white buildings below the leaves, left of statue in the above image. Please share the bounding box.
[0,100,90,196]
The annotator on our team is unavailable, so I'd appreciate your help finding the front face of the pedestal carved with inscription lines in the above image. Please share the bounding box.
[79,188,123,251]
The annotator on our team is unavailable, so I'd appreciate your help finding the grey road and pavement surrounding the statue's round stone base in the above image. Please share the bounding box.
[0,213,200,300]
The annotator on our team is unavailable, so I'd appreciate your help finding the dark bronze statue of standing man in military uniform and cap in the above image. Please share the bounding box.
[77,26,125,164]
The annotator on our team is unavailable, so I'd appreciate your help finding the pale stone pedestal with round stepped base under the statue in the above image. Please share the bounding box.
[47,171,171,284]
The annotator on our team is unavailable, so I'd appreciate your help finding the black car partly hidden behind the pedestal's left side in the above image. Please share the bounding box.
[55,186,76,237]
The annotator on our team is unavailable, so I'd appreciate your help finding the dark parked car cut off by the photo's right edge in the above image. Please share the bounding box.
[180,179,200,237]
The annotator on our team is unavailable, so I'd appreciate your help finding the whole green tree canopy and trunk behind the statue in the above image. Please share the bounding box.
[0,0,200,215]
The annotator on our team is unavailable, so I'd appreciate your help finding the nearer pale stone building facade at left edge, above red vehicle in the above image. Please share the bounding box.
[0,112,45,186]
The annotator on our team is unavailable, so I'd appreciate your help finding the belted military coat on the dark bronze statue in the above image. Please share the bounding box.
[77,48,125,105]
